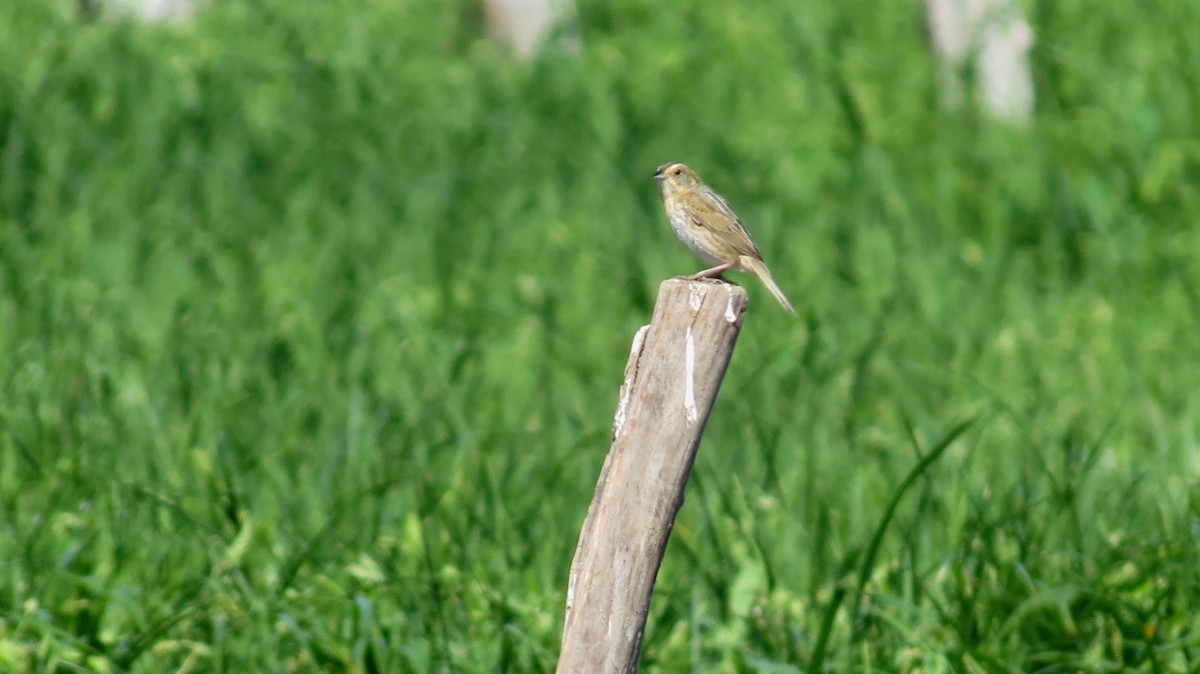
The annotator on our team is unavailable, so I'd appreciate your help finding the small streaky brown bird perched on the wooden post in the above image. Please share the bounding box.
[654,162,796,314]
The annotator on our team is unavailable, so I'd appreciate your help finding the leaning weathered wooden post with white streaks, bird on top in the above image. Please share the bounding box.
[557,278,746,674]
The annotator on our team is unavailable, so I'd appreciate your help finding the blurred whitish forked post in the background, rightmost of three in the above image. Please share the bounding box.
[925,0,1033,122]
